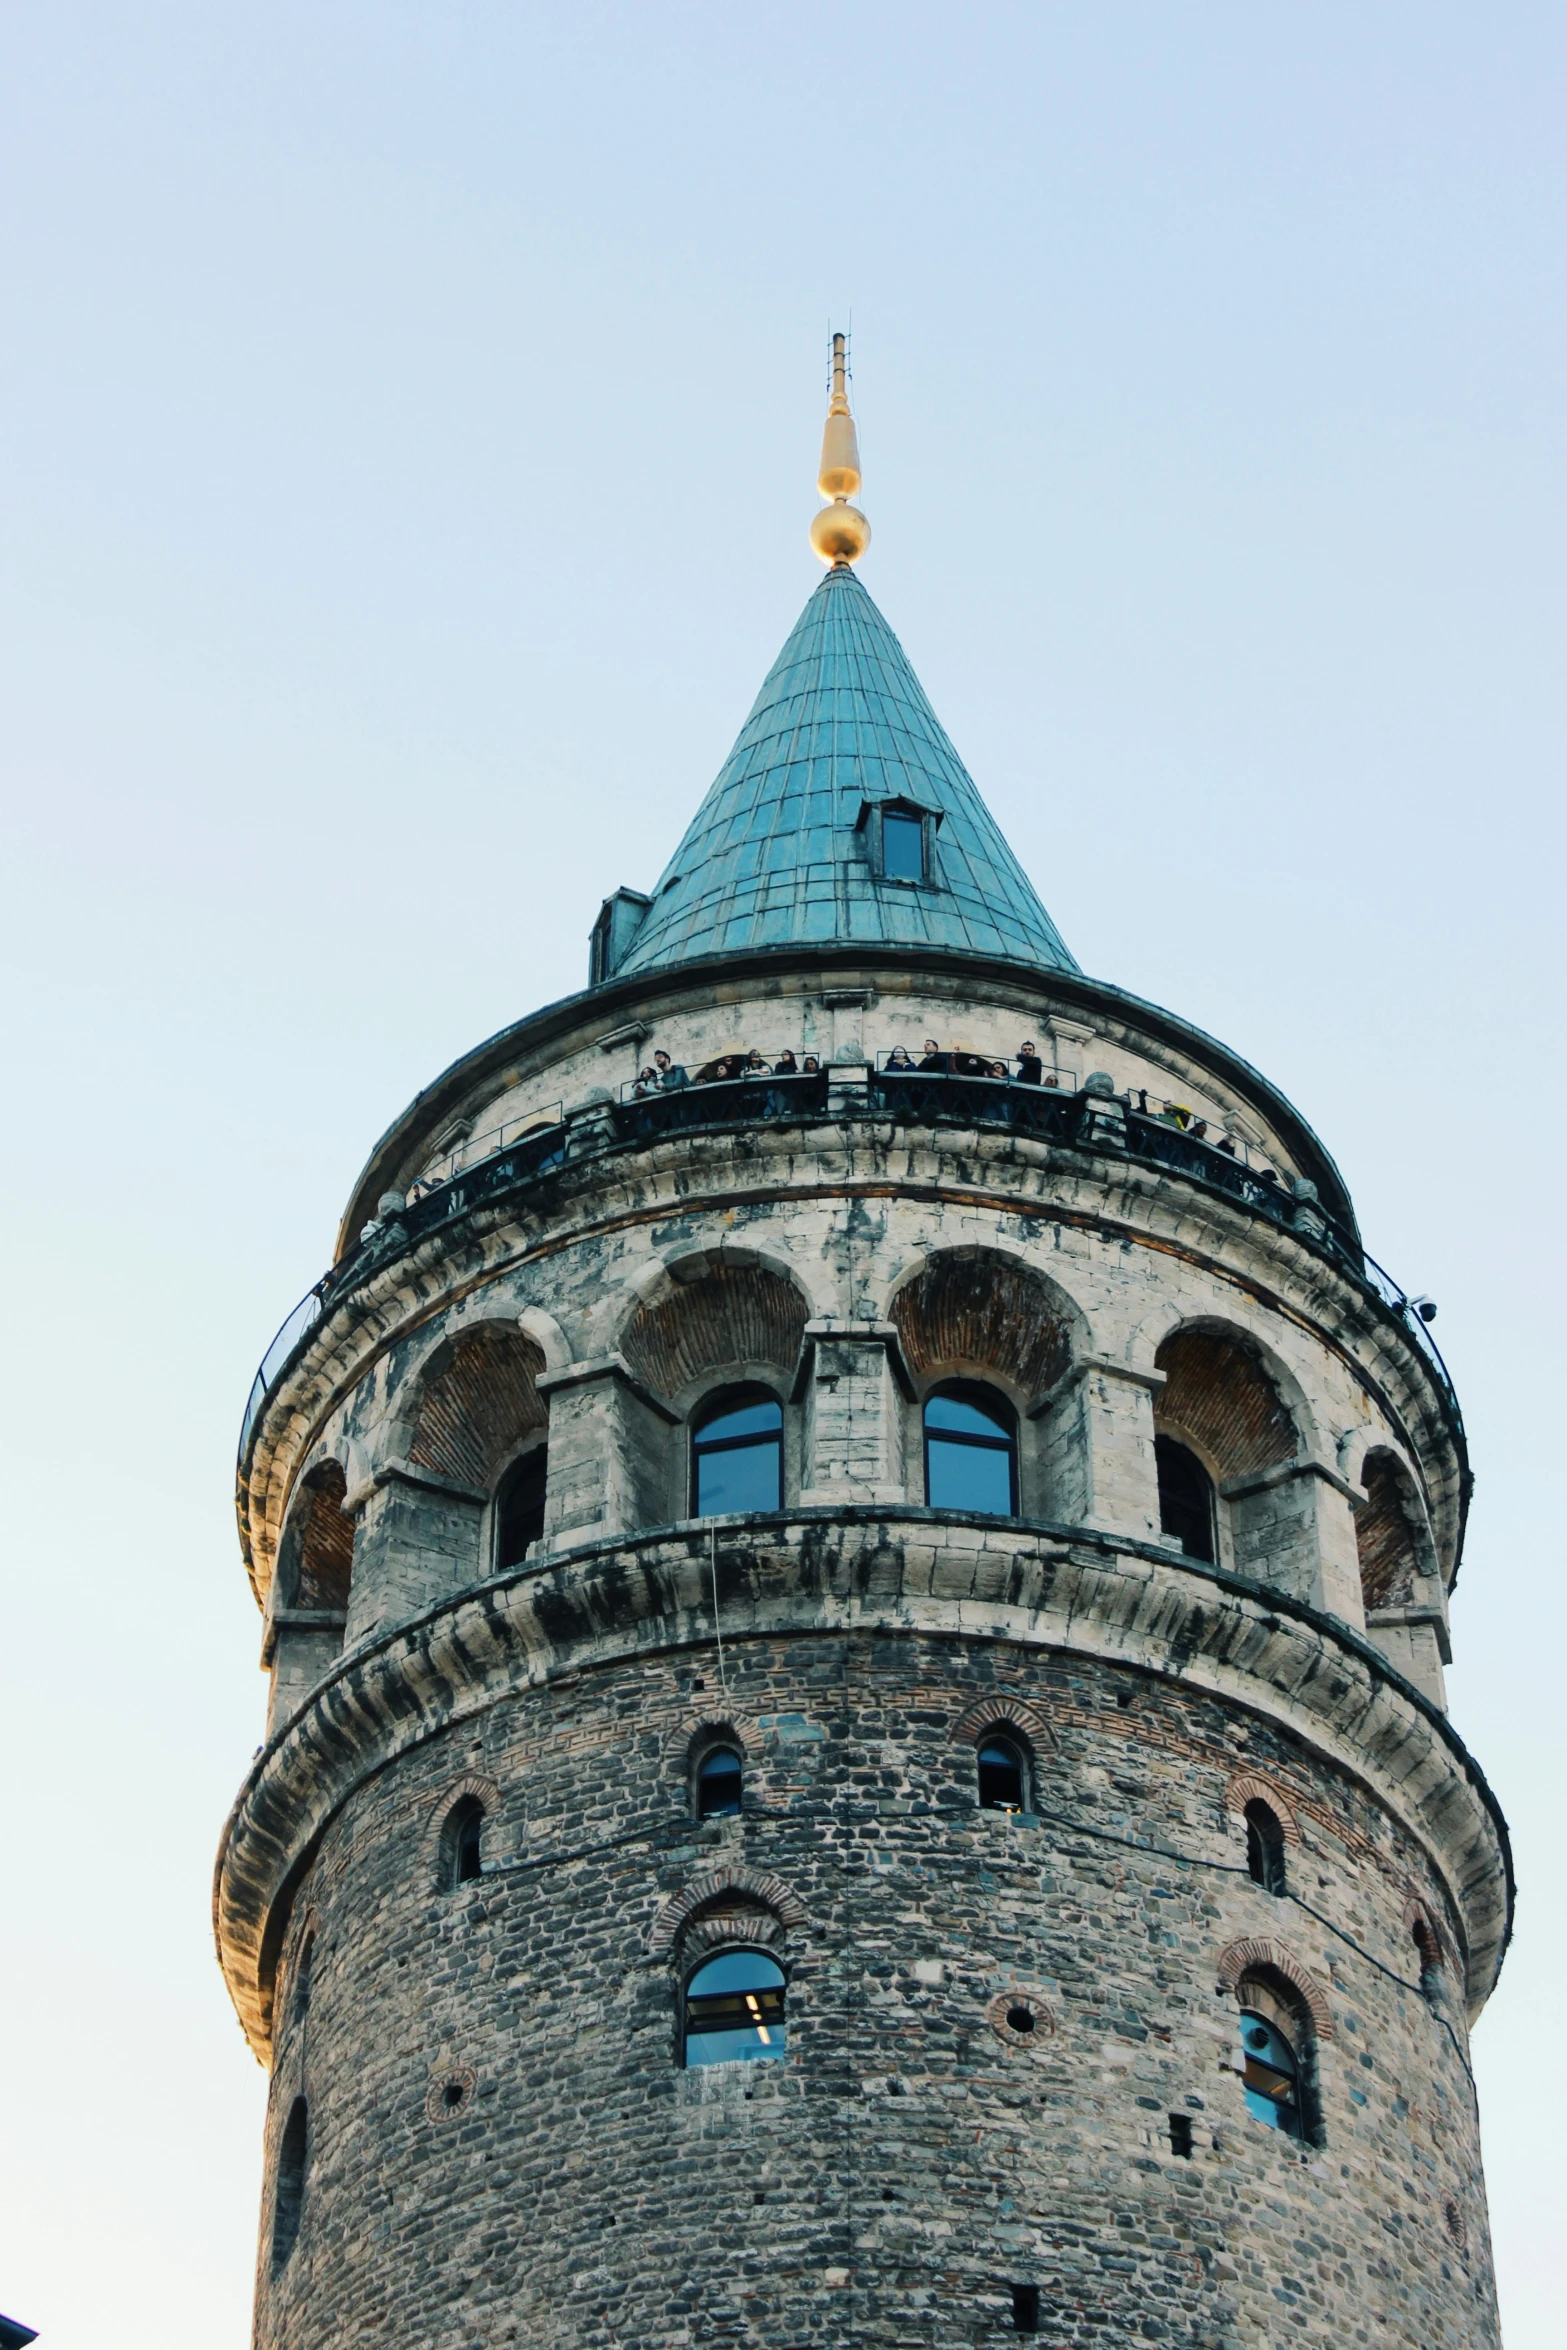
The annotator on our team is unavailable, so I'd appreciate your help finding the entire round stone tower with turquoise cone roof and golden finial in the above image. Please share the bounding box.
[216,347,1511,2350]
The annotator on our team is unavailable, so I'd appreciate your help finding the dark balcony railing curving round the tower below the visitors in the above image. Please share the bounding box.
[240,1055,1464,1459]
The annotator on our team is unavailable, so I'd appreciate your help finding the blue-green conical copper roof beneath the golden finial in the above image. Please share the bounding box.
[616,566,1078,975]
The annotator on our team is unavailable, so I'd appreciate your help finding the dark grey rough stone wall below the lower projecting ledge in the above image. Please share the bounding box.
[256,1631,1497,2350]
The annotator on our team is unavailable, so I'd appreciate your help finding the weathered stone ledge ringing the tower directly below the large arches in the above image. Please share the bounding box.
[214,1506,1513,2054]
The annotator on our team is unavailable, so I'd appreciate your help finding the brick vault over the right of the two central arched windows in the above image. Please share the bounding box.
[890,1248,1074,1396]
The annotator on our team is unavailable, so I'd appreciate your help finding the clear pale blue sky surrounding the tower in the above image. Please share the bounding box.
[0,0,1567,2350]
